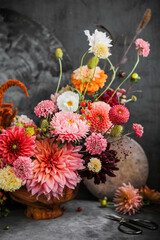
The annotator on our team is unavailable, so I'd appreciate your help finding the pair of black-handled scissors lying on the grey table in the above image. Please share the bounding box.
[105,214,158,235]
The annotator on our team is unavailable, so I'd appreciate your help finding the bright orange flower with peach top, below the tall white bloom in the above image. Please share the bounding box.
[71,65,107,95]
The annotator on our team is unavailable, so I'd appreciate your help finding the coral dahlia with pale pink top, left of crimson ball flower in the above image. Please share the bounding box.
[89,102,112,134]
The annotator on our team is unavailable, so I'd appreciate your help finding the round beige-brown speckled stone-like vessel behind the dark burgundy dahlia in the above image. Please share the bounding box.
[84,137,148,199]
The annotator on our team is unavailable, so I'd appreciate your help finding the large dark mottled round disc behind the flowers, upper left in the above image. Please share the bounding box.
[0,9,71,124]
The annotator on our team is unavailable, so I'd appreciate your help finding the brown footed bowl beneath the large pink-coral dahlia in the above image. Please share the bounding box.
[10,185,79,219]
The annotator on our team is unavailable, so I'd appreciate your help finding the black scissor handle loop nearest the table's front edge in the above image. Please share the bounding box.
[118,221,142,235]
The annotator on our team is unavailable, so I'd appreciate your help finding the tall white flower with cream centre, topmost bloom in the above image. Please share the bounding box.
[84,29,112,59]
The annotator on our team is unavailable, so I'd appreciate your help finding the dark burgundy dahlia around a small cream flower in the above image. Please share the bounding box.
[80,143,120,184]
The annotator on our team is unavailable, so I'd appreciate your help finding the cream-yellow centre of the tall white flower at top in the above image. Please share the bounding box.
[93,42,109,58]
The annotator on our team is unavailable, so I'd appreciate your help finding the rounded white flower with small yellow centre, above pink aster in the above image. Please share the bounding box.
[57,91,79,112]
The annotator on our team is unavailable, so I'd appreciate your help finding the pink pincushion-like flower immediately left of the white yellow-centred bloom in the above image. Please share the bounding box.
[34,100,58,118]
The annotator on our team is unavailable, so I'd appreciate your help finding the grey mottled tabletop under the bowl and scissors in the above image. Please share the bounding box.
[0,200,160,240]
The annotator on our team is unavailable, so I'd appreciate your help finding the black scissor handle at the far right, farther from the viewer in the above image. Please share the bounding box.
[127,219,158,230]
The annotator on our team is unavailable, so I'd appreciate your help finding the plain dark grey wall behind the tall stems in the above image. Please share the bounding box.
[0,0,160,197]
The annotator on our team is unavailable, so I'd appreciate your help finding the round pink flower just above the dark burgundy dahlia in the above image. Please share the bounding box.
[84,133,107,155]
